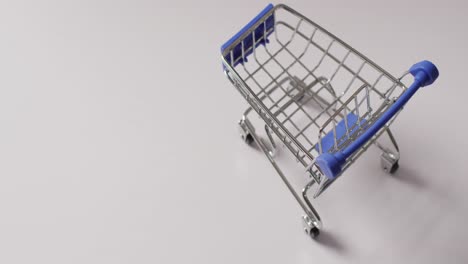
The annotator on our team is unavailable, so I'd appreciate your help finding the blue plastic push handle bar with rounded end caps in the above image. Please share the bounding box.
[316,61,439,179]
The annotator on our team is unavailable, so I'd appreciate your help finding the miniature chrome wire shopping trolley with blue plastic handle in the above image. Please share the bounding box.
[221,4,439,237]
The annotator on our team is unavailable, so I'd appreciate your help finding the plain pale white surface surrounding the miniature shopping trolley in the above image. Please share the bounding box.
[0,0,468,264]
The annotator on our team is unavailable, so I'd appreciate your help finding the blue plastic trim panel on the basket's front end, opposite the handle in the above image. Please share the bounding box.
[221,4,275,67]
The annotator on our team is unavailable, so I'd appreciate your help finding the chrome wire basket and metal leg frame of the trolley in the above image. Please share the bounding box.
[222,5,406,237]
